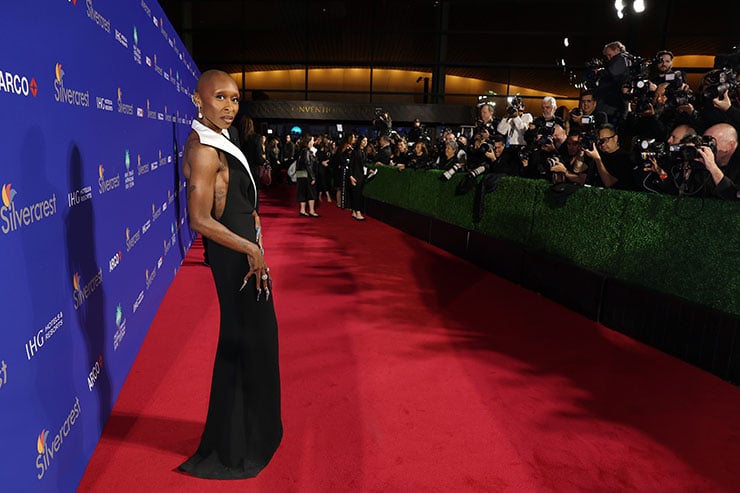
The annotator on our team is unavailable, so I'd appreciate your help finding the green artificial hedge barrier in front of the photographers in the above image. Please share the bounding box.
[365,165,740,315]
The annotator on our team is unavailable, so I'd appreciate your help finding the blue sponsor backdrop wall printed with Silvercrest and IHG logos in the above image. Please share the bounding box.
[0,0,199,492]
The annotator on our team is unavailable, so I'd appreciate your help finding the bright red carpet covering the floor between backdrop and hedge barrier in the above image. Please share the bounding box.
[79,185,740,493]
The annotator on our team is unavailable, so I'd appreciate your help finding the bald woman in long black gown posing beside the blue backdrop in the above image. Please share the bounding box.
[179,70,283,479]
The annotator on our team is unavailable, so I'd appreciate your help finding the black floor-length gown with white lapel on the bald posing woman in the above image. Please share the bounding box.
[179,122,283,479]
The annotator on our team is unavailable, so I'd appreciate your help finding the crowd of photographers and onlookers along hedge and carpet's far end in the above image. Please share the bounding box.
[238,41,740,207]
